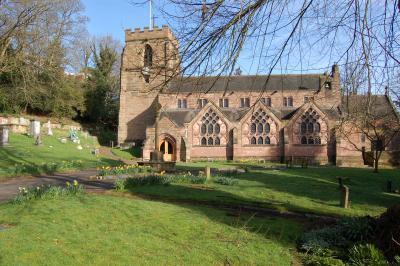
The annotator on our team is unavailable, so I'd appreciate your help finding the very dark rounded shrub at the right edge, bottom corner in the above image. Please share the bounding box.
[374,204,400,261]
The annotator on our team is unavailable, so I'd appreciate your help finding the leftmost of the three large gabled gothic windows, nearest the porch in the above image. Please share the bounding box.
[200,108,222,146]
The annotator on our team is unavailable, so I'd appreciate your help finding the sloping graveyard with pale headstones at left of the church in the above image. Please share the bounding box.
[0,120,115,180]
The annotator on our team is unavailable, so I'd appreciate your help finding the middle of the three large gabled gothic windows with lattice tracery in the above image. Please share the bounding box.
[249,108,273,145]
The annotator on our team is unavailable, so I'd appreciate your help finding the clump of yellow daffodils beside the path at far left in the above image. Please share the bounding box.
[13,180,84,203]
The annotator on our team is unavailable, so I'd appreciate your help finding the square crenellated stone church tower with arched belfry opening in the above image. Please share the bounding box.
[118,26,180,144]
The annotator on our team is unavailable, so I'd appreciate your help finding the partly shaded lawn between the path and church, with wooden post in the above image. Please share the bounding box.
[126,162,400,216]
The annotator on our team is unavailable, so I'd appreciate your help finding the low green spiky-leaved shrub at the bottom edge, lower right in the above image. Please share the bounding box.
[349,244,389,266]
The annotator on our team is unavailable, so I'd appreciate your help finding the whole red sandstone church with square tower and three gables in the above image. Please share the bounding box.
[118,26,396,164]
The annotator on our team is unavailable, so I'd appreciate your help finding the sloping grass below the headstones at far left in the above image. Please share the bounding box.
[0,130,114,180]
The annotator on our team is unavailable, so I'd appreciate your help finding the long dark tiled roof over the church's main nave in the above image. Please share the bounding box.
[164,74,321,93]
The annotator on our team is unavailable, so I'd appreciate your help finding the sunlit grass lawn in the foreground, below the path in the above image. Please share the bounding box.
[0,195,302,265]
